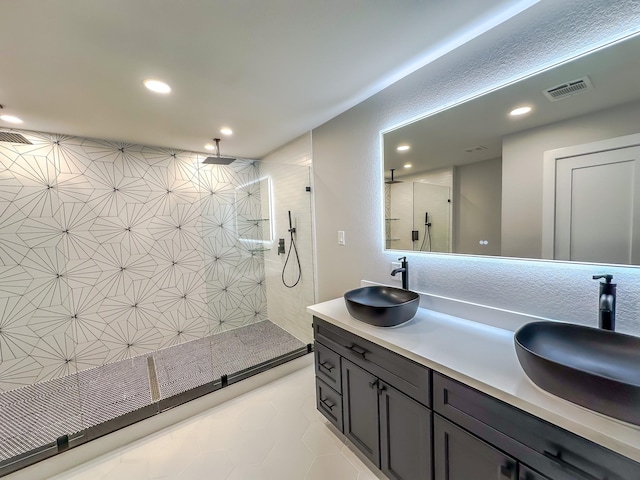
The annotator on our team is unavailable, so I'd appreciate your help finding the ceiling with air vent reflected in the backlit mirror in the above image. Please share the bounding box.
[384,36,640,178]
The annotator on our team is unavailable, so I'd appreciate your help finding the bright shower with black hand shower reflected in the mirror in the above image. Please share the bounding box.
[413,182,452,253]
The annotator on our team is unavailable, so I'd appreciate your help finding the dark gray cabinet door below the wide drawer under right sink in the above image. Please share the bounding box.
[433,414,517,480]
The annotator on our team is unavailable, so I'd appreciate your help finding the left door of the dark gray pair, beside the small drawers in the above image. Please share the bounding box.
[342,358,380,467]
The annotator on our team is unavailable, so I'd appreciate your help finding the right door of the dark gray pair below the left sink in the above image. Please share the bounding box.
[379,382,432,480]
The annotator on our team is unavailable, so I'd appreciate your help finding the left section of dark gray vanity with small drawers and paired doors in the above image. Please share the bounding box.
[314,319,432,480]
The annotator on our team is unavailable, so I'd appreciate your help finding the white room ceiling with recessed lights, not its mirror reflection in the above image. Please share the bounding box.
[0,0,535,158]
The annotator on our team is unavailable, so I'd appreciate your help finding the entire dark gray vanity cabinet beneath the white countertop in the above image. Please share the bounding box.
[314,318,640,480]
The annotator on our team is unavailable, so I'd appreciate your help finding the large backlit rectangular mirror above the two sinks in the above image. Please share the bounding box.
[383,33,640,264]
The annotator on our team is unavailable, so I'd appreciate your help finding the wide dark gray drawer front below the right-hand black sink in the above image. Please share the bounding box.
[433,372,640,480]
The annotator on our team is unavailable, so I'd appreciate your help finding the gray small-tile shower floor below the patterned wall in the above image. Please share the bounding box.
[0,320,304,461]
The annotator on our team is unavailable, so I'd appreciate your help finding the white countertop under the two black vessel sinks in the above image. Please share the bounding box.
[307,298,640,462]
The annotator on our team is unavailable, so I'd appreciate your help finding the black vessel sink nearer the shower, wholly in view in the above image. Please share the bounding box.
[344,285,420,327]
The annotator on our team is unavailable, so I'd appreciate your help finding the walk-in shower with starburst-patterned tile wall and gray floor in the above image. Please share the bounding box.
[0,130,313,475]
